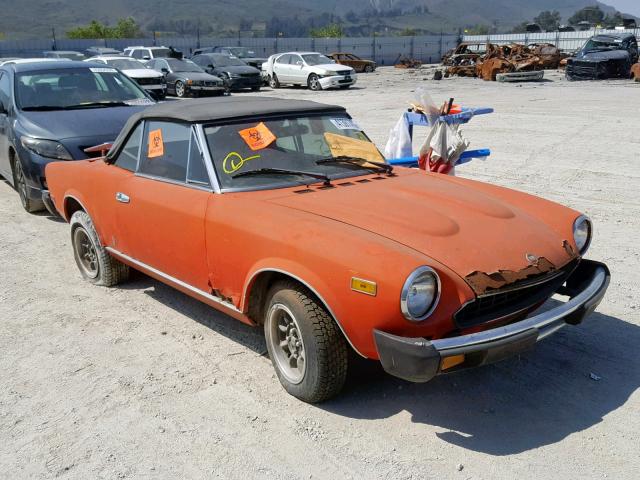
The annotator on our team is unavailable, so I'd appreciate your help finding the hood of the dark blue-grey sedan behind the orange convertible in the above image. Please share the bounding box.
[19,106,146,159]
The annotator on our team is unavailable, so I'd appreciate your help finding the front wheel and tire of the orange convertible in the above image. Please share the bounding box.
[264,281,349,403]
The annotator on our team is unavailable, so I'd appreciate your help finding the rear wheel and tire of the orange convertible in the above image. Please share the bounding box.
[69,210,129,287]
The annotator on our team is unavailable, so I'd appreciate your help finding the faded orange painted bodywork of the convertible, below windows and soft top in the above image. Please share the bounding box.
[46,161,579,359]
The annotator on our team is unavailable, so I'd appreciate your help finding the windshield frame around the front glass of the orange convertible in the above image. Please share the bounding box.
[198,110,384,193]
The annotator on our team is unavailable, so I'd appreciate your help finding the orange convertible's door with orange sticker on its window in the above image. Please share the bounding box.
[114,121,212,292]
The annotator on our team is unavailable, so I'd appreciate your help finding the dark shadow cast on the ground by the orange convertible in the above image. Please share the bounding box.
[120,272,640,456]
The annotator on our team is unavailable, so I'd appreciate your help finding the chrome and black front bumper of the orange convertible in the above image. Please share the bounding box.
[374,260,611,382]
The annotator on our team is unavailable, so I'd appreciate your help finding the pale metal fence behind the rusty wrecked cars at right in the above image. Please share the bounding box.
[463,29,640,52]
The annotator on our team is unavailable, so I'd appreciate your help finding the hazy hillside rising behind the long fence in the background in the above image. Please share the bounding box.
[0,0,624,39]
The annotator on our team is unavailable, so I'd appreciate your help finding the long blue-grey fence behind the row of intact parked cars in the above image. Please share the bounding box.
[0,35,460,65]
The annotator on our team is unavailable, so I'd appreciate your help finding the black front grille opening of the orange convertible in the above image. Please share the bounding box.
[453,259,579,329]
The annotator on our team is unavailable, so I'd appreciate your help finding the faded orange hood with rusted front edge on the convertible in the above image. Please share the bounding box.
[267,172,575,286]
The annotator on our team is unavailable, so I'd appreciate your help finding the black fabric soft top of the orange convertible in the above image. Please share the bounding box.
[108,96,345,157]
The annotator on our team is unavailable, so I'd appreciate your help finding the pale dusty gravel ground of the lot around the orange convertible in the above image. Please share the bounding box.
[0,68,640,479]
